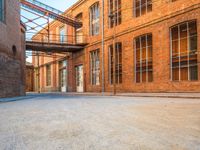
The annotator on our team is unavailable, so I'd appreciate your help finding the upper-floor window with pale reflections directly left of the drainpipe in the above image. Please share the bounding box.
[90,3,100,35]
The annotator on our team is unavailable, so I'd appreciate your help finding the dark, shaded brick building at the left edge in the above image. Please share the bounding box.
[0,0,25,97]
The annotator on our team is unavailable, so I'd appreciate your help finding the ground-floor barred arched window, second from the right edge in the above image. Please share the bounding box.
[135,34,153,83]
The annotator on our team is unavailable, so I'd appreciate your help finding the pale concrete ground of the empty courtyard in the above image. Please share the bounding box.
[0,94,200,150]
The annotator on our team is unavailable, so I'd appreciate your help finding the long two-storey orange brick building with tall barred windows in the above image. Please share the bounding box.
[33,0,200,92]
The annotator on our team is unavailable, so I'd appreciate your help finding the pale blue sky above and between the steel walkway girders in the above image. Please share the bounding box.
[24,0,78,62]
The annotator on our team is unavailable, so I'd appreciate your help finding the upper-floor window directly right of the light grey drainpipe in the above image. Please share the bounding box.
[109,0,122,28]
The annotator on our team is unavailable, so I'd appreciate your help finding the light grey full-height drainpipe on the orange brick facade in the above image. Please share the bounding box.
[101,0,105,95]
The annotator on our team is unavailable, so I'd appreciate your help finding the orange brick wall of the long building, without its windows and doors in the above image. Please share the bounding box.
[32,0,200,92]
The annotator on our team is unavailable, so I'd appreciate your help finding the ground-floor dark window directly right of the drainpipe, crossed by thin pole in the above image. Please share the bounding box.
[109,43,122,84]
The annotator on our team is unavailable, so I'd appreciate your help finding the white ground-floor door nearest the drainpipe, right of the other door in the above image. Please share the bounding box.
[76,65,83,92]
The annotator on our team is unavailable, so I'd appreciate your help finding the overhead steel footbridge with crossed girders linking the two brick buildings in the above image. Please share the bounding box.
[20,0,86,53]
